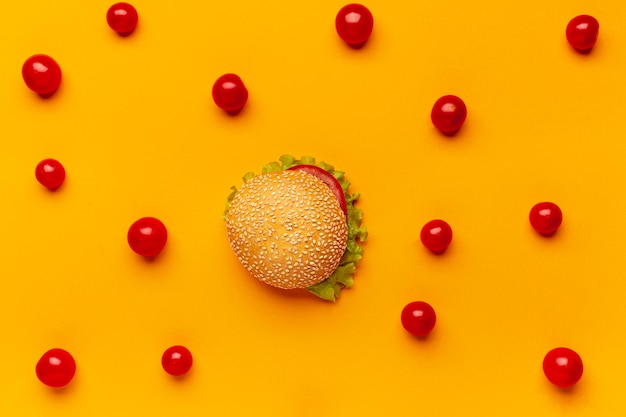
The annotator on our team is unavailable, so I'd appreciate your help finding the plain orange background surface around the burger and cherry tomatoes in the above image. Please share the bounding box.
[0,0,626,417]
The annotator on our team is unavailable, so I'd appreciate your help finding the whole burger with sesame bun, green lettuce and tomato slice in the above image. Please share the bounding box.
[223,155,367,301]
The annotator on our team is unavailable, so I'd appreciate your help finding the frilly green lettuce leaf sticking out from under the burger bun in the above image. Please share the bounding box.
[222,155,367,301]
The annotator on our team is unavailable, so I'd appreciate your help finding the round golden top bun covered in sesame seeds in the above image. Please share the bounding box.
[226,170,348,289]
